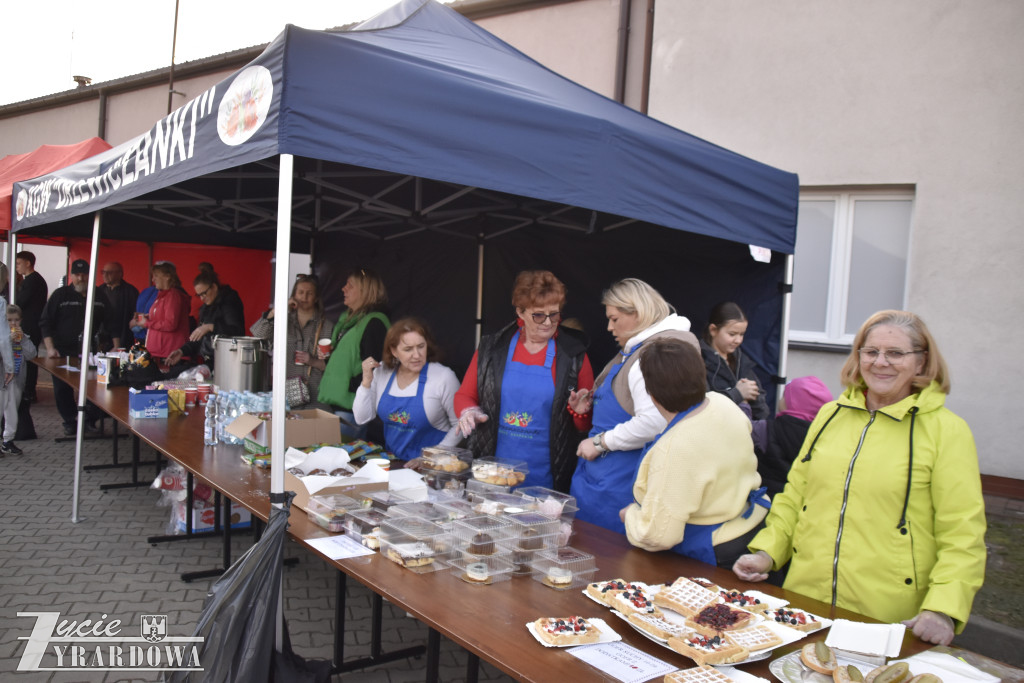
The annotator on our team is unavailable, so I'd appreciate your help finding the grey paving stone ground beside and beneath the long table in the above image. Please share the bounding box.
[0,385,513,683]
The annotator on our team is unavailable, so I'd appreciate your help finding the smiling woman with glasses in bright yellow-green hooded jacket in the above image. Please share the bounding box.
[733,310,985,645]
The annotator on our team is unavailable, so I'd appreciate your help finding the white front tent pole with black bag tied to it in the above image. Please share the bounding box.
[270,155,295,652]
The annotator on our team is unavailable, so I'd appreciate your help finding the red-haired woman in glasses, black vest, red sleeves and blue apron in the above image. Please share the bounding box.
[456,270,594,493]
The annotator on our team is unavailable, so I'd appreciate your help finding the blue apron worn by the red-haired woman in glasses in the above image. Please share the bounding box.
[492,332,555,488]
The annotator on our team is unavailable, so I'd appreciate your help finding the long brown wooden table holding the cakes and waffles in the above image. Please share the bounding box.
[38,358,991,681]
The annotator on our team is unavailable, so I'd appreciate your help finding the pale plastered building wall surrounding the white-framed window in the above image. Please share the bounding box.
[650,0,1024,478]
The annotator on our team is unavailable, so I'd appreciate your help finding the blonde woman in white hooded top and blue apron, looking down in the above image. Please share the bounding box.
[569,278,697,533]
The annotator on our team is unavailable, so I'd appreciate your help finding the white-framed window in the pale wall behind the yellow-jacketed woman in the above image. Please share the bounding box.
[790,189,913,344]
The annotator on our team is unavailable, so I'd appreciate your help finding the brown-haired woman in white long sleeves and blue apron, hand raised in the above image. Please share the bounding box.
[352,317,460,461]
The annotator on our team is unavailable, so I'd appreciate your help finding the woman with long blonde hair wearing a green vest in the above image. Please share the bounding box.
[316,268,391,439]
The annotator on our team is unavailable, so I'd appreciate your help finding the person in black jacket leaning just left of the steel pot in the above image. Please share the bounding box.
[167,271,246,370]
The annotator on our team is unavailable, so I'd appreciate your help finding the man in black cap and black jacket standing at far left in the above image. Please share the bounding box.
[39,259,105,436]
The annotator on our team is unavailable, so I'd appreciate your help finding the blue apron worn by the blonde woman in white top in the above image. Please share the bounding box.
[569,344,646,533]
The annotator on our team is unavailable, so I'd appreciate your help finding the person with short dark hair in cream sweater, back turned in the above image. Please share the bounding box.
[621,339,771,567]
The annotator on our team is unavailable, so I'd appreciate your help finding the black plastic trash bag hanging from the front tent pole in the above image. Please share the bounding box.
[164,492,331,683]
